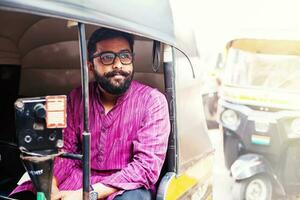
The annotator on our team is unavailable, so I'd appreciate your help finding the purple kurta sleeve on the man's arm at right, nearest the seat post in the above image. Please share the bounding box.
[101,90,170,190]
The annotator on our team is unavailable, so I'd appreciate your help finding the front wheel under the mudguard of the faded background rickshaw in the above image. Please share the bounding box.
[232,175,272,200]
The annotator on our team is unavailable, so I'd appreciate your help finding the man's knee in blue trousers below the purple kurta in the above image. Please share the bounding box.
[114,189,152,200]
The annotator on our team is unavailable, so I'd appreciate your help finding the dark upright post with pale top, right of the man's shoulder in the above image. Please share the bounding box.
[163,45,178,173]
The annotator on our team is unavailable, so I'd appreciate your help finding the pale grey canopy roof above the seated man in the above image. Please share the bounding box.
[0,0,176,46]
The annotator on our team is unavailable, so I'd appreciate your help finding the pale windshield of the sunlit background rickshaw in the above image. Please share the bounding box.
[224,48,300,92]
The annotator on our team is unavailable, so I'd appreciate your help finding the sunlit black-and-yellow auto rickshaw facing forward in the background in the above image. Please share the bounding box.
[219,39,300,200]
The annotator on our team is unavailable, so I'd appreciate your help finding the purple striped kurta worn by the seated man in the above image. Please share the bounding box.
[14,81,170,199]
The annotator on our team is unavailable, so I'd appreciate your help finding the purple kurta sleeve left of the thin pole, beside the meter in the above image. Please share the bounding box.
[53,91,81,186]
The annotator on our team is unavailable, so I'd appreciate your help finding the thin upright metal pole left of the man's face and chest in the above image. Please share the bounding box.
[78,22,90,200]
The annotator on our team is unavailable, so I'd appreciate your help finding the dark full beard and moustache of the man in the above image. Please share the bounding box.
[94,69,134,95]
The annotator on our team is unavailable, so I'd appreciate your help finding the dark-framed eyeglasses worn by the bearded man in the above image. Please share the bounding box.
[92,51,134,65]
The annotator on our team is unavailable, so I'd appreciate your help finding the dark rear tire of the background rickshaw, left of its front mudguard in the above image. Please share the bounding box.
[224,134,240,169]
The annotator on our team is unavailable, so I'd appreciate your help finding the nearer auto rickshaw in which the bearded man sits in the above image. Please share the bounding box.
[0,0,214,200]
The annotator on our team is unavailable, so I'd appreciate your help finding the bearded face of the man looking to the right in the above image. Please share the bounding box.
[89,37,133,95]
